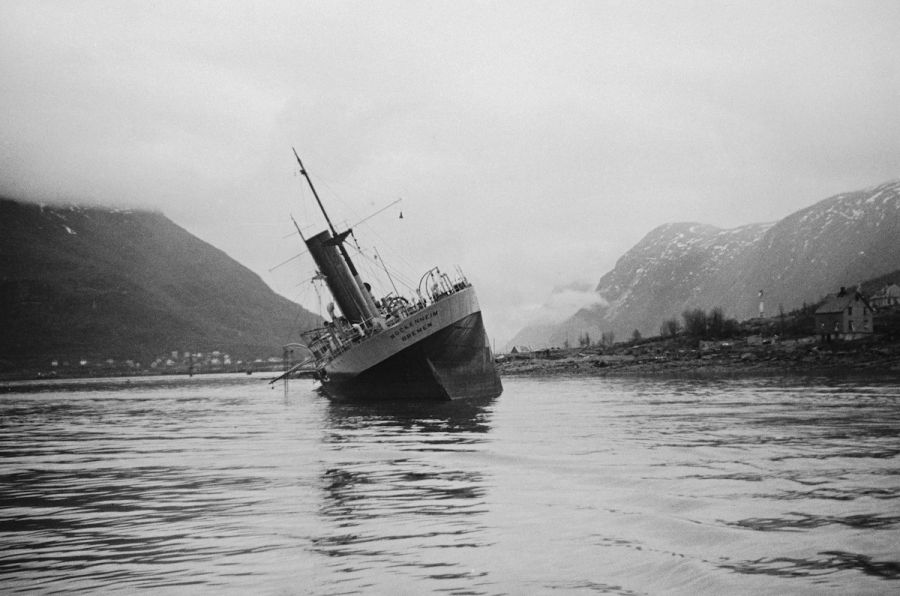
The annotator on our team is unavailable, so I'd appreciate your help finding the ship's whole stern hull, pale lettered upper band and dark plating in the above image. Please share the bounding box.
[320,288,503,401]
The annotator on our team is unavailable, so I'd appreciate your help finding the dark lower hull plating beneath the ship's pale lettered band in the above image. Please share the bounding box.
[322,312,503,401]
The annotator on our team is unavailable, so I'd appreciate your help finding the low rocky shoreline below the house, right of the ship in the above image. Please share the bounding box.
[497,341,900,378]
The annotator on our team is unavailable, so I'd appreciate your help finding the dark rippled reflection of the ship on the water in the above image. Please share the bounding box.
[312,398,494,591]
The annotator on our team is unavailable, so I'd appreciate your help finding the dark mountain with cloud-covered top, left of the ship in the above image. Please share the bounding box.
[0,199,317,369]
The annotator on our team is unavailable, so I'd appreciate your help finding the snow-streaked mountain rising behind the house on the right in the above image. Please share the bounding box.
[511,181,900,346]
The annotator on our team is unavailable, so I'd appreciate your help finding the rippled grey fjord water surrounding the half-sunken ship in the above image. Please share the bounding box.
[0,376,900,594]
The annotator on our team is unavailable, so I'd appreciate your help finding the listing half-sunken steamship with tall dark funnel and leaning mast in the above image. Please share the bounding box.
[294,151,503,401]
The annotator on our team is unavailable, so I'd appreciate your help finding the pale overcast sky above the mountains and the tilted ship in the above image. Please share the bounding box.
[0,0,900,346]
